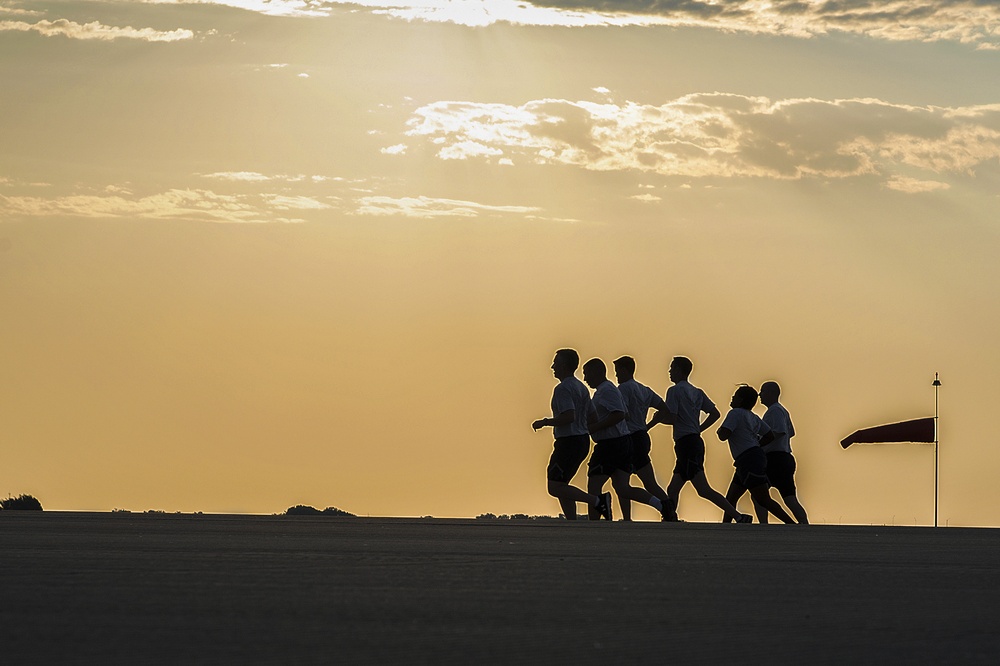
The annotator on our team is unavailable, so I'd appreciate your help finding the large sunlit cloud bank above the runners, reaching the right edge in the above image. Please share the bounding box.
[406,93,1000,189]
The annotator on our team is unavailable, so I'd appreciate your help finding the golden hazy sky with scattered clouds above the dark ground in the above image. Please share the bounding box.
[0,0,1000,525]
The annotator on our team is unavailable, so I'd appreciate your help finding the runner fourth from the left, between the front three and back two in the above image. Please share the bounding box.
[649,356,753,523]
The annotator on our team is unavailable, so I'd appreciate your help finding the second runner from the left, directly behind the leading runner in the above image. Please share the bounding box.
[583,358,663,520]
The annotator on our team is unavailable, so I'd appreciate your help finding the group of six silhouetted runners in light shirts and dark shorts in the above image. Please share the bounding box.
[531,349,808,524]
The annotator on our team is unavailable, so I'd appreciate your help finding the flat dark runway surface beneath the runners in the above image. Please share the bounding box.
[0,511,1000,665]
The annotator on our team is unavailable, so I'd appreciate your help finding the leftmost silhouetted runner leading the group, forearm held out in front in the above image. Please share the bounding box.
[531,349,611,520]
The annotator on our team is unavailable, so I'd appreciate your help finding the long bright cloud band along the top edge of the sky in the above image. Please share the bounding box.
[193,0,1000,48]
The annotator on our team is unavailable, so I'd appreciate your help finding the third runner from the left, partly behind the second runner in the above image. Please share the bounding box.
[614,356,677,521]
